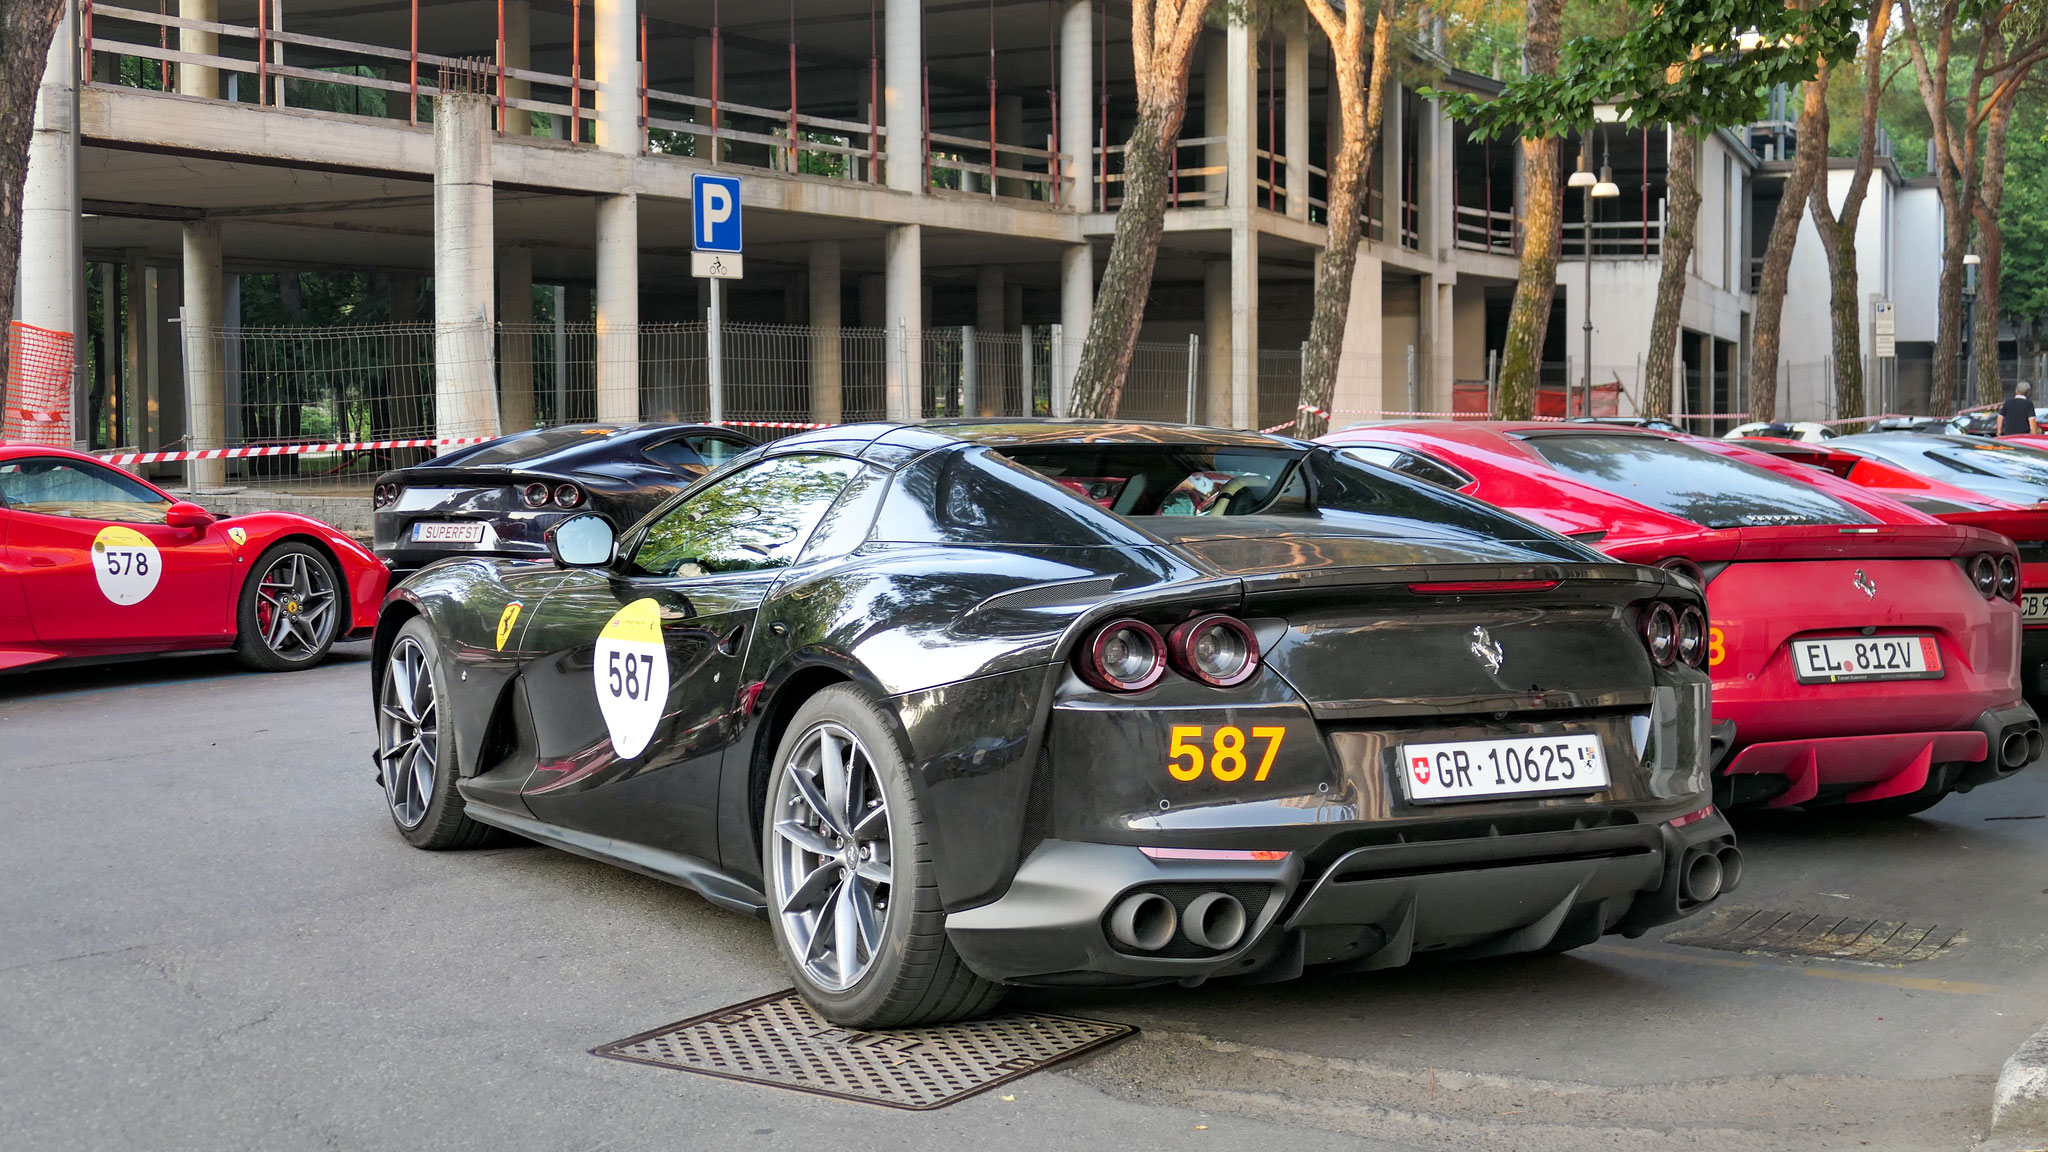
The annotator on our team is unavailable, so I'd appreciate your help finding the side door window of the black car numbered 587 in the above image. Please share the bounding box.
[633,455,862,576]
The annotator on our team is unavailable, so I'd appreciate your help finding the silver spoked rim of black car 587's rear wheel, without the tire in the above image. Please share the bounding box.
[770,719,895,992]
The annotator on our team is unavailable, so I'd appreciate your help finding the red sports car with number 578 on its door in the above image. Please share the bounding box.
[0,445,389,672]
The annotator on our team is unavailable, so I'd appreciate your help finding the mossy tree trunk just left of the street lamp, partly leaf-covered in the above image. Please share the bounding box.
[1495,0,1565,420]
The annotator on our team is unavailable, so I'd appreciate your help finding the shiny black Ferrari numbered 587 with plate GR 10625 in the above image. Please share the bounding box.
[373,422,1741,1027]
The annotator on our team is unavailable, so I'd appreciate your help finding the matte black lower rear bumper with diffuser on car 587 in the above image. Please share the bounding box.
[946,812,1741,984]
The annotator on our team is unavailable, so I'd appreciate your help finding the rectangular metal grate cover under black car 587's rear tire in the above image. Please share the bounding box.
[590,992,1137,1109]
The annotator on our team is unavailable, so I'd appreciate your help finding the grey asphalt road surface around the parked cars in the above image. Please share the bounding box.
[0,646,2048,1152]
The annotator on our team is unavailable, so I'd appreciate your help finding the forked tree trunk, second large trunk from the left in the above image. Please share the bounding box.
[1294,0,1393,439]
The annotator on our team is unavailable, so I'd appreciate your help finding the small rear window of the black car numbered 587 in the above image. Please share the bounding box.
[1001,445,1309,517]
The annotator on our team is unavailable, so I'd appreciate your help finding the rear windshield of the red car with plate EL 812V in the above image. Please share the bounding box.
[1528,435,1870,529]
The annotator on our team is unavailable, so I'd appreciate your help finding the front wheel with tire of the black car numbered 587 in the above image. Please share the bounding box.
[377,617,496,851]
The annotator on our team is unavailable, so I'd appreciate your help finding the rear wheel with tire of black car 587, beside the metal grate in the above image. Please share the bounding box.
[760,685,1004,1029]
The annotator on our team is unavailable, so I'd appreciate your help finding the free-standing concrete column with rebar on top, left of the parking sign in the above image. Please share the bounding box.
[434,92,502,438]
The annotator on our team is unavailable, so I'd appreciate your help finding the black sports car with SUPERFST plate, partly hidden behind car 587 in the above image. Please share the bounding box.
[371,424,754,580]
